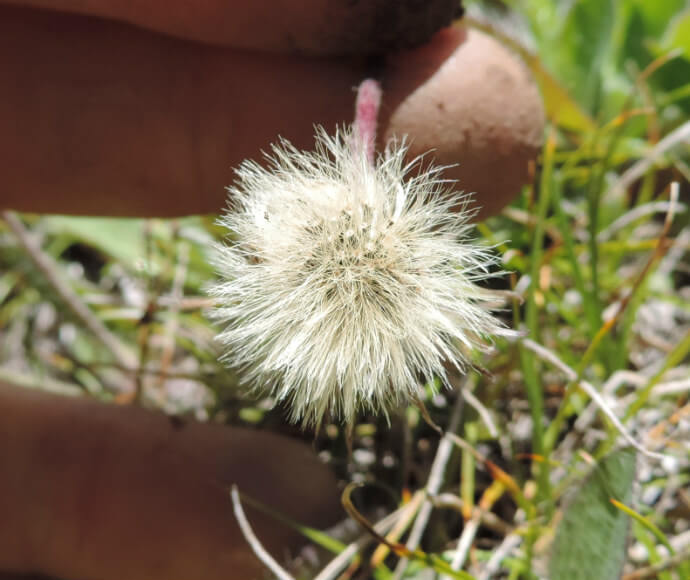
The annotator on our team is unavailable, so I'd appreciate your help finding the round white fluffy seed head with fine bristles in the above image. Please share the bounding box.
[211,129,507,425]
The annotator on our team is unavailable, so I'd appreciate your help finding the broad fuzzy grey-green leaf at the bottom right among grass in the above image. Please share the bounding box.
[549,448,635,580]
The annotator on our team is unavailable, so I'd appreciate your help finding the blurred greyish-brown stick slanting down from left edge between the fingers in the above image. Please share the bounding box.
[2,211,137,371]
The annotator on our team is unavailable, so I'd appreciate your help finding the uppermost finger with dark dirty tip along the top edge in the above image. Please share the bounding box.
[5,0,460,55]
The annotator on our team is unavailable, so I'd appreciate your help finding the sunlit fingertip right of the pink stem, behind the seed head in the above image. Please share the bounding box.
[384,27,544,219]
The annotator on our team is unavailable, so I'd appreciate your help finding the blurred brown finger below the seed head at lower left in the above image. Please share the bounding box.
[0,384,341,580]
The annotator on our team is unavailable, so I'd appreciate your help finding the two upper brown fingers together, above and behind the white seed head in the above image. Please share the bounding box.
[0,0,543,216]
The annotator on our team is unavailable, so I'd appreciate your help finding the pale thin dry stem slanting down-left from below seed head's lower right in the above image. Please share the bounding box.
[394,378,465,580]
